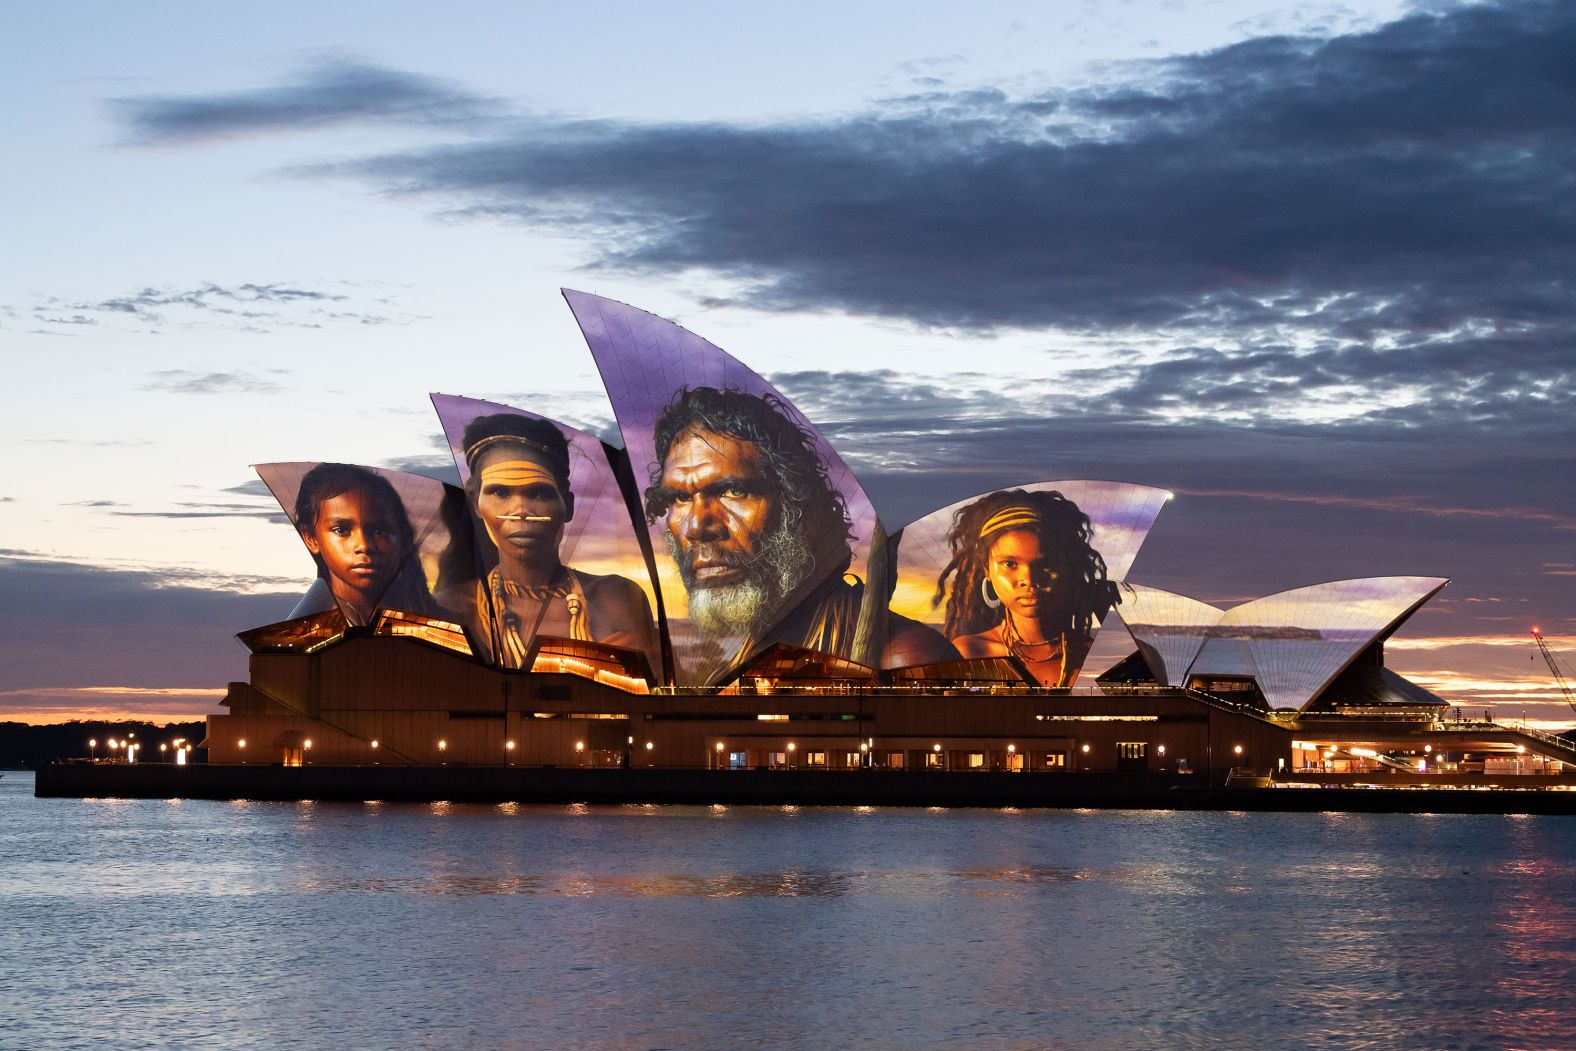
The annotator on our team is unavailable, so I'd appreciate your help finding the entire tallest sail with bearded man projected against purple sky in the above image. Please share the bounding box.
[564,290,957,685]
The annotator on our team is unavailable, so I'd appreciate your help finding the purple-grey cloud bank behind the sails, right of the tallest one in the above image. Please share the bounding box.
[759,365,1576,633]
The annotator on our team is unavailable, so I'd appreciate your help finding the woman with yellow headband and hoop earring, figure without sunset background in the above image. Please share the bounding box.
[931,488,1121,687]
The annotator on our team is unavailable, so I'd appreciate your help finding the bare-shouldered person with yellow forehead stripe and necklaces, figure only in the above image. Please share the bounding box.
[444,413,662,670]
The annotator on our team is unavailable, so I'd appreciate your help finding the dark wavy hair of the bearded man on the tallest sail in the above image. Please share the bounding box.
[645,386,854,566]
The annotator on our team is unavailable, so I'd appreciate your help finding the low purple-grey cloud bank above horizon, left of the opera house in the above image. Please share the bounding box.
[0,551,299,689]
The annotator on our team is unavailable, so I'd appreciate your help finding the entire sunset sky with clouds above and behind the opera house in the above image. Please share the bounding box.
[0,0,1576,726]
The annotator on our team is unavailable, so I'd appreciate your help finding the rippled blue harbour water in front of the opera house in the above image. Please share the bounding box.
[9,772,1576,1048]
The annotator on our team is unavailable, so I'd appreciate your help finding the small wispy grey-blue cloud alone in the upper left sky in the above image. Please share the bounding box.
[112,60,493,143]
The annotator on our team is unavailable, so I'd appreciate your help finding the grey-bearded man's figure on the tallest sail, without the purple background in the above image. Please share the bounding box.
[645,388,958,665]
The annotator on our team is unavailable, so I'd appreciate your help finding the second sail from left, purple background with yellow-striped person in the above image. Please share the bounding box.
[435,399,662,670]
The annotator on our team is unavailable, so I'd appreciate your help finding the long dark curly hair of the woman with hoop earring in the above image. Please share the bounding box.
[930,488,1121,638]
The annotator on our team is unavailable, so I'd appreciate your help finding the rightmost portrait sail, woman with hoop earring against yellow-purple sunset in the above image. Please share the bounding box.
[889,481,1168,687]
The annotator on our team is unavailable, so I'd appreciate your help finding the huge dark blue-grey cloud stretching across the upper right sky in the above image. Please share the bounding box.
[245,3,1576,339]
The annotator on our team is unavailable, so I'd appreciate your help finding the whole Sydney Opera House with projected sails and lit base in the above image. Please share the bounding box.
[205,292,1576,785]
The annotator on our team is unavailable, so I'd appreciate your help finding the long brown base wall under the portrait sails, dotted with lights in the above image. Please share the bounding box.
[208,637,1291,778]
